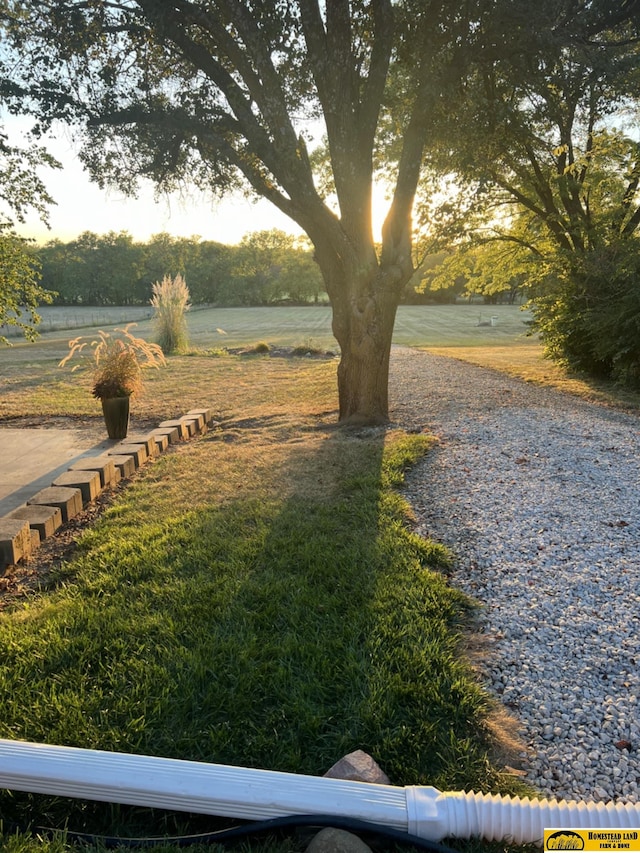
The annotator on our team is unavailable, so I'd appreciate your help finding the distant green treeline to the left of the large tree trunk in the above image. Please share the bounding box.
[34,229,327,306]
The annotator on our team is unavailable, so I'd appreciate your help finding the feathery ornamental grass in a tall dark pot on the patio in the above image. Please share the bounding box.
[60,323,165,439]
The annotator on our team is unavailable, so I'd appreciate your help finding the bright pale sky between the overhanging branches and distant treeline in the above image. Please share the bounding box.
[3,117,301,245]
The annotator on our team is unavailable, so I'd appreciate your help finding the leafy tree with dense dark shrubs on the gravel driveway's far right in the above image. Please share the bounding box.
[422,0,640,383]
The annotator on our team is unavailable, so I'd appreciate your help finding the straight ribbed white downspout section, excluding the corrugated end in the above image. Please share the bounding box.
[0,740,407,830]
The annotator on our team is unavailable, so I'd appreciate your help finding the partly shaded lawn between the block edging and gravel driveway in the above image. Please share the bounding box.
[0,348,528,853]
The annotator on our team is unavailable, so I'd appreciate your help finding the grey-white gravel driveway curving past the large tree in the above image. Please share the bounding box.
[390,348,640,802]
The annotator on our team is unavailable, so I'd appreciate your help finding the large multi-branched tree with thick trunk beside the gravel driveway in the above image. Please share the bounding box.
[2,0,476,422]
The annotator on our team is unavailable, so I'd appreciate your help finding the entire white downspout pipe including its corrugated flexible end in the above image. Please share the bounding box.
[0,740,640,844]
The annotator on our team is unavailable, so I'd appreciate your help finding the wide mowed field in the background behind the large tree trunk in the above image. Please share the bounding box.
[0,304,640,419]
